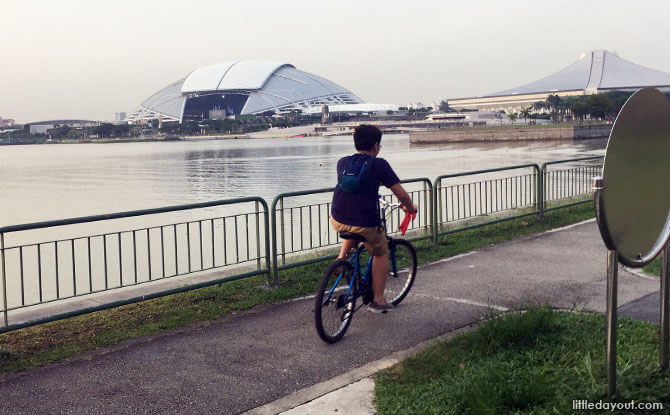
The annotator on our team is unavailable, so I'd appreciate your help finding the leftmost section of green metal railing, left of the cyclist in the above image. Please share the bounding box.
[0,197,270,332]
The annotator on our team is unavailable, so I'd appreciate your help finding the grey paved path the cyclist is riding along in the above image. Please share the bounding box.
[0,220,659,414]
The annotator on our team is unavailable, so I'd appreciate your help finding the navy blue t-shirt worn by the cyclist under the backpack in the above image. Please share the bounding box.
[331,156,400,227]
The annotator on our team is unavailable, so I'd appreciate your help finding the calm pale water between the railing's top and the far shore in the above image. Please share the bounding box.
[0,135,606,226]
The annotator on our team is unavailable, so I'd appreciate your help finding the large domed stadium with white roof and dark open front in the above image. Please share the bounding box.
[128,60,363,122]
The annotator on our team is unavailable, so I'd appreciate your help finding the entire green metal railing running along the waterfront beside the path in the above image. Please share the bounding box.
[0,157,603,333]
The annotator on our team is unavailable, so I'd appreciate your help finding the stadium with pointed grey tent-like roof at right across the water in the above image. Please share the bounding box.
[448,50,670,111]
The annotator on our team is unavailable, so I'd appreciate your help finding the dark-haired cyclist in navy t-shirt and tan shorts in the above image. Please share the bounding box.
[330,125,417,313]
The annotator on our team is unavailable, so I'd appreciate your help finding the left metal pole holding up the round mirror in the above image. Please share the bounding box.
[607,250,619,398]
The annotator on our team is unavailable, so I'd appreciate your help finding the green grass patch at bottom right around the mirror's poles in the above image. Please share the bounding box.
[375,308,670,415]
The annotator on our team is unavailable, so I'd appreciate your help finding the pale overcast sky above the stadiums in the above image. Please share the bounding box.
[0,0,670,123]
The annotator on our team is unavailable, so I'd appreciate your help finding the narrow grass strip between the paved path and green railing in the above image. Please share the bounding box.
[0,203,593,374]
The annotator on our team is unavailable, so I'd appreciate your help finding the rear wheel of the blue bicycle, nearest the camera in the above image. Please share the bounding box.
[314,259,355,343]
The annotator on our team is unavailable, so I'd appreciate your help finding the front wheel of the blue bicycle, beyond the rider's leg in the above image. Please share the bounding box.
[384,239,416,305]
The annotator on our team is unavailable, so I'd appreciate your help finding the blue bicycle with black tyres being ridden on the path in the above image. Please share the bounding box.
[314,197,417,343]
